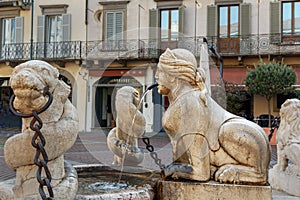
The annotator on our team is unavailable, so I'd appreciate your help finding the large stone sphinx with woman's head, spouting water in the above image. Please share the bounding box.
[155,49,271,185]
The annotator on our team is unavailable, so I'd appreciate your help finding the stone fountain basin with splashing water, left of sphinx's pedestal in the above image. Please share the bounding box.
[73,165,160,200]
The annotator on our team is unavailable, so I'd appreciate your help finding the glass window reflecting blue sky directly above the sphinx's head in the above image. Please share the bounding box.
[160,9,179,41]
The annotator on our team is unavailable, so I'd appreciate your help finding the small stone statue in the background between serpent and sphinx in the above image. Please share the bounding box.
[107,86,146,166]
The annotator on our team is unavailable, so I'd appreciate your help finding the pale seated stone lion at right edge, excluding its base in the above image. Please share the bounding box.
[275,99,300,173]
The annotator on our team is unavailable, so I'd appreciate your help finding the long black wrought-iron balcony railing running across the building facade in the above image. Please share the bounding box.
[0,34,300,62]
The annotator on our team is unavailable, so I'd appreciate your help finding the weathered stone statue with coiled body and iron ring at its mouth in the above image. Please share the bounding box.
[4,60,78,199]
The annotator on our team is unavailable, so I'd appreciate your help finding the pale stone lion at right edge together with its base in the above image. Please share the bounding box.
[269,99,300,197]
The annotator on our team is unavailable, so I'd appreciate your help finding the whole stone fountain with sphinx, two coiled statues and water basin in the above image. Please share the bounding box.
[0,49,272,199]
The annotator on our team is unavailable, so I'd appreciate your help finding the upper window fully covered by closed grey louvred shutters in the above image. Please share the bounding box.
[105,11,124,50]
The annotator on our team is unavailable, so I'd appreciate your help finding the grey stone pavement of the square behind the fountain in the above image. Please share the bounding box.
[0,131,300,200]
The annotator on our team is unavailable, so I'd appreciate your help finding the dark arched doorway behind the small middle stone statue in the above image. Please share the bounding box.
[94,76,143,127]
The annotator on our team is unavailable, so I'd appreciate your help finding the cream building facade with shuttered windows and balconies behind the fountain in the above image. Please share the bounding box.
[0,0,300,132]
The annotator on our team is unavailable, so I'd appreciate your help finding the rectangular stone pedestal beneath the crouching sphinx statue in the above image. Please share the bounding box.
[158,181,272,200]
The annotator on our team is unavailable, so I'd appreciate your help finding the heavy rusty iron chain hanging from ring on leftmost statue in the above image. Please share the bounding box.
[9,87,54,200]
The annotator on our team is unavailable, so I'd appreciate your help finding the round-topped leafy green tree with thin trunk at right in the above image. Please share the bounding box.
[245,61,297,127]
